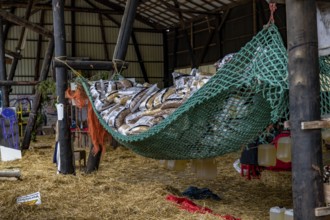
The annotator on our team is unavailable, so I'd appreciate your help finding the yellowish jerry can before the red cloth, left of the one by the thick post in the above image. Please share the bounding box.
[258,144,276,167]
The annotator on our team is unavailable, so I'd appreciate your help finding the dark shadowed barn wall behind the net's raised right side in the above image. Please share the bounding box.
[167,0,286,83]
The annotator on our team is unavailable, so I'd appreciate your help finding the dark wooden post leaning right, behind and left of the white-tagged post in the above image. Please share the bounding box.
[22,38,54,150]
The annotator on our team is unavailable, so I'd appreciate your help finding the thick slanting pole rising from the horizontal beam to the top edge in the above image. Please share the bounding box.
[113,0,139,60]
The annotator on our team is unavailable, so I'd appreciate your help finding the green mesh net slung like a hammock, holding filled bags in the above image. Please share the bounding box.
[82,25,330,159]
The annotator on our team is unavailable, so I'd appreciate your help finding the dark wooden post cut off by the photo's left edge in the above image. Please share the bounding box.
[0,18,9,107]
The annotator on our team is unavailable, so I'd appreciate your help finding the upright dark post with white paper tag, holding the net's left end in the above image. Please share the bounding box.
[52,0,75,174]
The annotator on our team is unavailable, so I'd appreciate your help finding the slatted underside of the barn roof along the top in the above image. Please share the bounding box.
[0,0,262,29]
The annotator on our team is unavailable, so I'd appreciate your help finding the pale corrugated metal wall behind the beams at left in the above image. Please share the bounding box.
[5,1,164,95]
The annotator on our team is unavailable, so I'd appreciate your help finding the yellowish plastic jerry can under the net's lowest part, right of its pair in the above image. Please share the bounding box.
[192,158,217,179]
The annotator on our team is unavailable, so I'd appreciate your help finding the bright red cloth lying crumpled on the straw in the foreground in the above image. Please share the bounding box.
[166,195,240,220]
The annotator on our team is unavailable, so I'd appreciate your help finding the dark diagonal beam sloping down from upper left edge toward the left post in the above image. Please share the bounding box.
[0,9,53,37]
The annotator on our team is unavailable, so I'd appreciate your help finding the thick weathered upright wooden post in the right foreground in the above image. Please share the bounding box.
[286,0,324,220]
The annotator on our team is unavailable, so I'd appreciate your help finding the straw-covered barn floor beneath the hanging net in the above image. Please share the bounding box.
[0,136,292,220]
